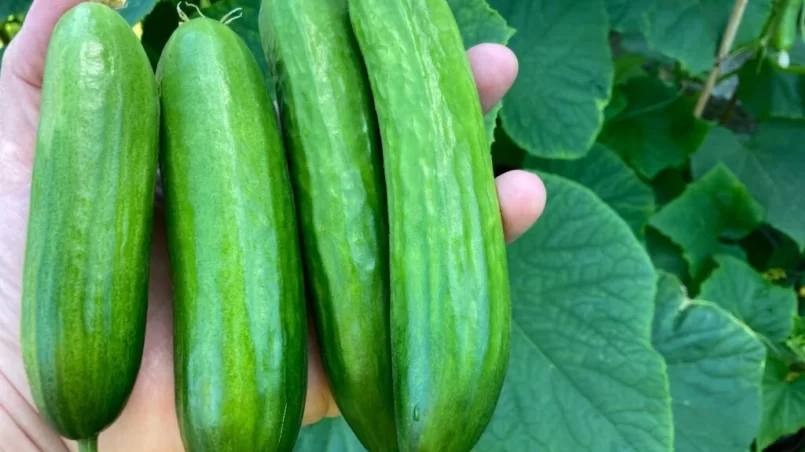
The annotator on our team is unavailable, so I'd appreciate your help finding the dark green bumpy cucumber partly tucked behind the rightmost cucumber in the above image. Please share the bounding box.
[260,0,396,451]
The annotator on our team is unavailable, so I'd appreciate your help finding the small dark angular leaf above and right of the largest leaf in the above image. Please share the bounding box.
[649,165,763,279]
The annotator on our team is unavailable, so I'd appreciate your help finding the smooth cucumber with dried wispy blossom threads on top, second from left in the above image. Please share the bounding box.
[157,18,307,452]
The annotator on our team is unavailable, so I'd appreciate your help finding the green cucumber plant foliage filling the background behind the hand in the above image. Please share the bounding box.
[6,0,805,452]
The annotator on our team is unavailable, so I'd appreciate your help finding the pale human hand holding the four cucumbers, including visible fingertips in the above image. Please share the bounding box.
[0,0,545,451]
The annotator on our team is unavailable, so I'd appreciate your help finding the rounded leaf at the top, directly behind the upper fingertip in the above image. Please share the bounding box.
[490,0,613,158]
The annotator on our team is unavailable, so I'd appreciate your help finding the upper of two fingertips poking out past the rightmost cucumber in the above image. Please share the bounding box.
[467,44,519,113]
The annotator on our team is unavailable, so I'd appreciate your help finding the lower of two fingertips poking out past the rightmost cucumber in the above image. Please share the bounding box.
[495,170,547,243]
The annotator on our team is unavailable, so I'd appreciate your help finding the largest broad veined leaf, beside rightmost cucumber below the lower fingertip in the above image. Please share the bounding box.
[477,173,672,452]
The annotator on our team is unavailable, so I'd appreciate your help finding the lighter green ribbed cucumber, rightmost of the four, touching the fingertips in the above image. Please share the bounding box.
[349,0,511,451]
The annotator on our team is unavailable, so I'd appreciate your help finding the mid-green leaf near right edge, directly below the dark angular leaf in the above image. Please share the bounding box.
[699,256,797,342]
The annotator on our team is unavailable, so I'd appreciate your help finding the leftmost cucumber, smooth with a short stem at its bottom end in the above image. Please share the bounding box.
[21,3,159,439]
